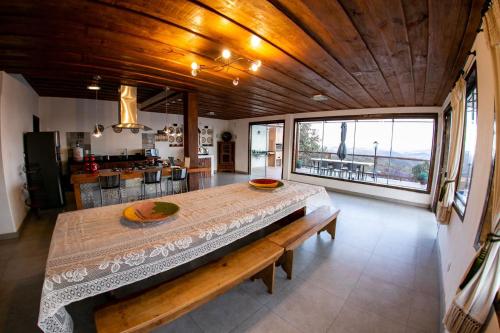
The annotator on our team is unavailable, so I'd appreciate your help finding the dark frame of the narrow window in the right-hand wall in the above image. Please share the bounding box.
[452,63,479,222]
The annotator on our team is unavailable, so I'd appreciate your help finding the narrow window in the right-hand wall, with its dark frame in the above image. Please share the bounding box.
[455,67,477,216]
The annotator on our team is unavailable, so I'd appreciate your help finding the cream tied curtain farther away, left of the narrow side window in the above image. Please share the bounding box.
[436,76,467,224]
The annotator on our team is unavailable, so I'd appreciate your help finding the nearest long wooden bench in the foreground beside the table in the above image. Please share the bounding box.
[95,238,284,333]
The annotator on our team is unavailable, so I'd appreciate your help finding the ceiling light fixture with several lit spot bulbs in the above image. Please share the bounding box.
[191,49,262,86]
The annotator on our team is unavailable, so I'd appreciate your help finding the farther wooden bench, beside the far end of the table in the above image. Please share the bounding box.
[266,206,340,279]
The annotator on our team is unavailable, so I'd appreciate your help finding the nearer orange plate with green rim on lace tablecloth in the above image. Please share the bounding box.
[123,201,179,223]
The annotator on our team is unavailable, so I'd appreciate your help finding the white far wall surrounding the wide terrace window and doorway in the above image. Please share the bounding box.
[229,107,442,206]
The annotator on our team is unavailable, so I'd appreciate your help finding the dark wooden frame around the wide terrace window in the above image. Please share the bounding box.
[290,112,439,194]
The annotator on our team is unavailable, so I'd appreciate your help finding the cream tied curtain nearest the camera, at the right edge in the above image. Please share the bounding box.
[444,1,500,333]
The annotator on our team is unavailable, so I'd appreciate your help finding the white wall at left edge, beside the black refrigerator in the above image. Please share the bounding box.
[0,72,38,234]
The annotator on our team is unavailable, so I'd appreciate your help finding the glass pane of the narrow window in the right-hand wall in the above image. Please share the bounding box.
[456,83,477,208]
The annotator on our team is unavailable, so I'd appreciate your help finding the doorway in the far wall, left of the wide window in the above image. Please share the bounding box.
[248,121,285,179]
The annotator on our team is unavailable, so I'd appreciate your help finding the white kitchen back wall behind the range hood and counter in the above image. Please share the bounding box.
[39,97,227,167]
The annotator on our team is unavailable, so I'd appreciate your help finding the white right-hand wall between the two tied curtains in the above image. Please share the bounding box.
[438,32,499,316]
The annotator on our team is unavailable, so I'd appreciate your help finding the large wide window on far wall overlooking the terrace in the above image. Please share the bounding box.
[293,114,436,192]
